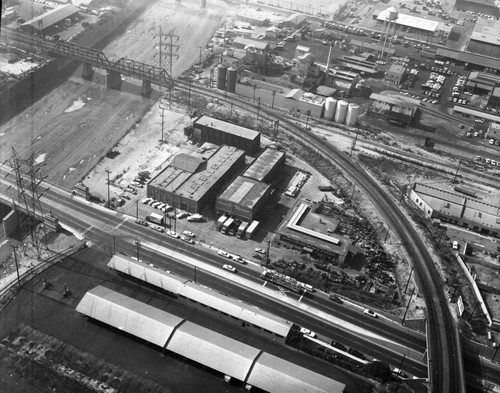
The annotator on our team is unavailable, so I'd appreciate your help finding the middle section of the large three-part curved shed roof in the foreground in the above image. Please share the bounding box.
[167,322,262,381]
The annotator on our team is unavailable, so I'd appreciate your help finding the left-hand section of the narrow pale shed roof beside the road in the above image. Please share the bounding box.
[107,255,189,294]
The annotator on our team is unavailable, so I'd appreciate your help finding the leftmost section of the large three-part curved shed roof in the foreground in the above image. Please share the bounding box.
[76,286,183,347]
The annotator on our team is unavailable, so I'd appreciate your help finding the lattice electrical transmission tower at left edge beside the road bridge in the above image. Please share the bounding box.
[10,148,47,258]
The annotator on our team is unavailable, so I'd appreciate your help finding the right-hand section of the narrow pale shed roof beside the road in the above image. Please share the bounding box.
[179,282,293,337]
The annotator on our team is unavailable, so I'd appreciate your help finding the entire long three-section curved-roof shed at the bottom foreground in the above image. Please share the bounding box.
[76,286,345,393]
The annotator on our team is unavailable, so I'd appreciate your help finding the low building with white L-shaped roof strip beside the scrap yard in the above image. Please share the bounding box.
[275,200,358,263]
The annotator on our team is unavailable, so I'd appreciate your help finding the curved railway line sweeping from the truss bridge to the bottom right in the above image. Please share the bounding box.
[175,81,466,393]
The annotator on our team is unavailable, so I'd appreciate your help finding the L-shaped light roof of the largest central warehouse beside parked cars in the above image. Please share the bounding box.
[149,145,245,201]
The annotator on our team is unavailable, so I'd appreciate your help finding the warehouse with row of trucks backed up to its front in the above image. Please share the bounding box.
[215,176,271,221]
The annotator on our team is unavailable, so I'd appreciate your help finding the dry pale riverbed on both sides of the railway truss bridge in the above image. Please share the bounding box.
[0,0,226,188]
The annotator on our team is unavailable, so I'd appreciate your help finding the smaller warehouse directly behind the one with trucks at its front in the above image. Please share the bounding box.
[243,147,286,183]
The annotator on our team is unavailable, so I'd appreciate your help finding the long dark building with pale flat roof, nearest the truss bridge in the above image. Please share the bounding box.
[192,116,260,155]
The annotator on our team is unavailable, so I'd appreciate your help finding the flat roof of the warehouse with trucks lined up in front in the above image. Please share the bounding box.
[218,176,271,208]
